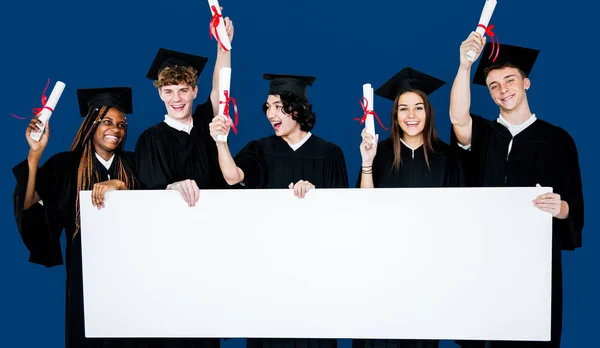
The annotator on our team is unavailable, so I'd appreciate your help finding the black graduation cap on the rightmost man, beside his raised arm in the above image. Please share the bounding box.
[473,42,540,86]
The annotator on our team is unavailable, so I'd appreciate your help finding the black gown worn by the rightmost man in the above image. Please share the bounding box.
[451,116,583,348]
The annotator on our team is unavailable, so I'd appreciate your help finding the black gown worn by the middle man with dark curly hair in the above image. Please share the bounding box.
[235,134,348,188]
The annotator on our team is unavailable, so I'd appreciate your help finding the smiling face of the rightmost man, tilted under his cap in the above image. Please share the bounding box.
[485,67,531,111]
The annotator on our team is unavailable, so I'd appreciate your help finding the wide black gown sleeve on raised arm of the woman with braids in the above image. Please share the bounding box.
[13,158,63,267]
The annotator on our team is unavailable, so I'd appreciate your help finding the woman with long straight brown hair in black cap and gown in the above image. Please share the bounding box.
[357,68,460,188]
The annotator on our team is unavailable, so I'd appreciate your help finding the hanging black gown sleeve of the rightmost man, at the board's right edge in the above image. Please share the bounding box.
[553,131,583,250]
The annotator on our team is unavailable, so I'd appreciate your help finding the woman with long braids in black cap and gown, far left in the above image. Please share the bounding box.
[13,87,139,348]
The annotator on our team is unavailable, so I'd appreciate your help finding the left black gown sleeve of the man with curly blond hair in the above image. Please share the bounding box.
[134,129,173,190]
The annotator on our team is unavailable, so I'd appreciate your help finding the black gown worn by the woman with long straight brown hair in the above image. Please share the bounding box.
[356,138,464,188]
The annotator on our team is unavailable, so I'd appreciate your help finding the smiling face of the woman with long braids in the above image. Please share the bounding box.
[94,108,127,154]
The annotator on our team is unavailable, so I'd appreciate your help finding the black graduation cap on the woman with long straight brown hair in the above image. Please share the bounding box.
[375,67,446,101]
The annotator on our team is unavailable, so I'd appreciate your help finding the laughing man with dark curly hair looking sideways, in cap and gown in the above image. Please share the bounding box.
[210,74,348,198]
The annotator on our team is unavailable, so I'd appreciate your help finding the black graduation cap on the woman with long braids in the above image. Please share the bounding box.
[77,87,133,117]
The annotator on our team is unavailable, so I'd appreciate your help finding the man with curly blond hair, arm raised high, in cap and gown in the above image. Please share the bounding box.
[135,18,233,207]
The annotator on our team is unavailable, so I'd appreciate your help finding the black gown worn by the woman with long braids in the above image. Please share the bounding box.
[13,152,149,348]
